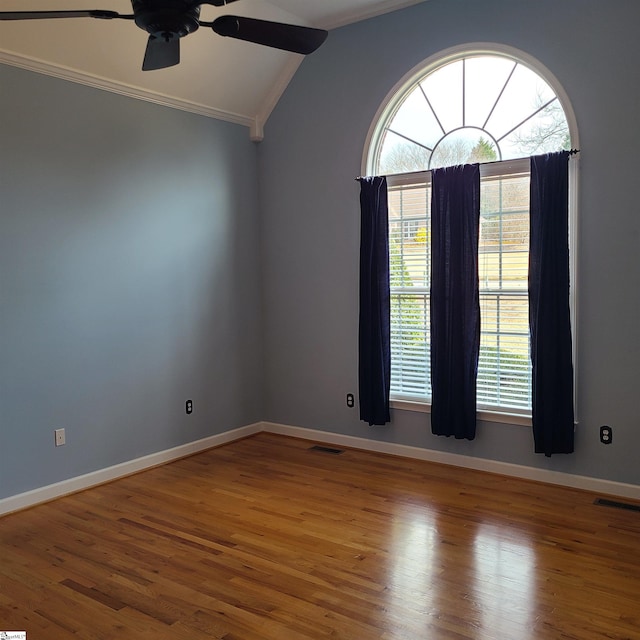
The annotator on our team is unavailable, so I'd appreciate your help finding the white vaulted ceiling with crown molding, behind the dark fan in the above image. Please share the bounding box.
[0,0,424,140]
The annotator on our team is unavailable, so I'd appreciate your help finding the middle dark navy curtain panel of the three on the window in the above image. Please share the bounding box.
[431,164,480,440]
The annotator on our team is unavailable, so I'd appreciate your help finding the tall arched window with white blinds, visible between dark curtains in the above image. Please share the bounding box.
[364,45,577,416]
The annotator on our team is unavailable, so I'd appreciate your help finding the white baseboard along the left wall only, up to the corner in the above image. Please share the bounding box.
[0,423,262,516]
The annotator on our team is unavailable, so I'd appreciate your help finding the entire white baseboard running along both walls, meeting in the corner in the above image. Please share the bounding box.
[0,422,640,516]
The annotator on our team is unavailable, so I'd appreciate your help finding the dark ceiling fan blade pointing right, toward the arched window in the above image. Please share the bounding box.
[212,16,329,54]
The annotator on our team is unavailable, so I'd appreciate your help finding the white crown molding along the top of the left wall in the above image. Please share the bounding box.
[0,49,256,130]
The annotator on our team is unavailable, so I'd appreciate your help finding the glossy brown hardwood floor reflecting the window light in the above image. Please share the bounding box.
[0,434,640,640]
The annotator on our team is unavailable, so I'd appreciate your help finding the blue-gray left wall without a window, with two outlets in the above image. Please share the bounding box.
[0,65,262,498]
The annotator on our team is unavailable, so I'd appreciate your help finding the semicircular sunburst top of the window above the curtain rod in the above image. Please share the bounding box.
[365,45,577,175]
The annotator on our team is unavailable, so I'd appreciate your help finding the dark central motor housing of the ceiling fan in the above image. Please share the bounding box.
[131,0,200,40]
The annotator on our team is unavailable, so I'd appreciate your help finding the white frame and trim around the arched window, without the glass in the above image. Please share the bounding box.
[361,43,580,426]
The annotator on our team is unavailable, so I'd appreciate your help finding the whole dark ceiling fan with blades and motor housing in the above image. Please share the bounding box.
[0,0,328,71]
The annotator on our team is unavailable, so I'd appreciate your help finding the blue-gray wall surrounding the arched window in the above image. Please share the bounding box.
[259,0,640,484]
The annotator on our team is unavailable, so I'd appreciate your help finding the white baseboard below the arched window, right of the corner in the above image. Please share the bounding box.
[262,422,640,500]
